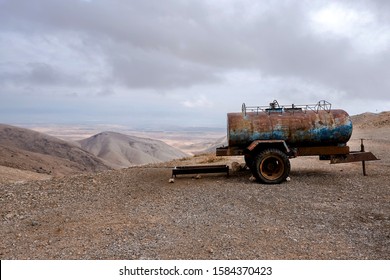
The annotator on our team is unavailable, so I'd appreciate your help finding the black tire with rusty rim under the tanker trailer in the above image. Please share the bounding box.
[252,149,291,184]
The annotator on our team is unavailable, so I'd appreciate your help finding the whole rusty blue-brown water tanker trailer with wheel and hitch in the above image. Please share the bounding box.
[217,100,377,184]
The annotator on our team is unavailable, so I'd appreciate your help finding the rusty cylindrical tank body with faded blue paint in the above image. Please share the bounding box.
[228,110,352,147]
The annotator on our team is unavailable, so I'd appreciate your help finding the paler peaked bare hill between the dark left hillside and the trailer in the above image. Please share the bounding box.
[78,131,188,168]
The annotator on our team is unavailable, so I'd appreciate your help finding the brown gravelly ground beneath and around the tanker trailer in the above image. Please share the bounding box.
[0,116,390,259]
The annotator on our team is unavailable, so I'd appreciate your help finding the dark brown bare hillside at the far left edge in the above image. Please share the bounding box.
[0,124,109,175]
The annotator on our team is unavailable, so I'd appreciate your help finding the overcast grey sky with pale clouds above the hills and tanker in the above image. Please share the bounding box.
[0,0,390,127]
